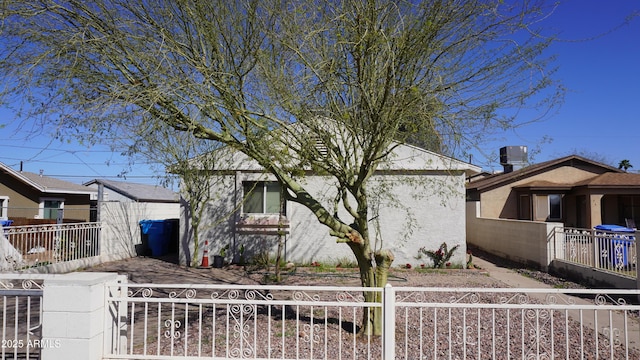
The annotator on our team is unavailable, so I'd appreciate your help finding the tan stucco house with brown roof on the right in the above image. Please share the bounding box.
[467,155,640,228]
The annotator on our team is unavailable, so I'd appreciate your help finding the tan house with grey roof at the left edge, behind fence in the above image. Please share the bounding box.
[0,163,96,225]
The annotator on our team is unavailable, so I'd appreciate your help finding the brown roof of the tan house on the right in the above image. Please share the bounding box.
[467,155,622,191]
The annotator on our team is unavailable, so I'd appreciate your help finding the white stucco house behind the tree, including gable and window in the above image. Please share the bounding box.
[180,145,480,266]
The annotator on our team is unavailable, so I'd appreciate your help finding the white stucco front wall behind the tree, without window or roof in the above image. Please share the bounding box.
[180,171,466,266]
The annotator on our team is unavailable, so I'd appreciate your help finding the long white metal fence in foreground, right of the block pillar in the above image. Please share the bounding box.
[105,284,640,359]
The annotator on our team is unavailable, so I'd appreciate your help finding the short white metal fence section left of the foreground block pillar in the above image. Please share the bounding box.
[0,278,42,359]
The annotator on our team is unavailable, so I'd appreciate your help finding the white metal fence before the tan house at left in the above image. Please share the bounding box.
[2,222,101,270]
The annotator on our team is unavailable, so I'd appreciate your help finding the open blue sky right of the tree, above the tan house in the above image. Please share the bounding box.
[476,0,640,170]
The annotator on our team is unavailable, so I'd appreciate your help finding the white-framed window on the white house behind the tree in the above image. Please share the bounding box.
[242,181,284,214]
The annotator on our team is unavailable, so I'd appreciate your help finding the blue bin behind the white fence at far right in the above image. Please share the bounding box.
[594,224,636,269]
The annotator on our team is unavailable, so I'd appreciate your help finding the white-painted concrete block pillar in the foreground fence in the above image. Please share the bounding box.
[40,272,122,360]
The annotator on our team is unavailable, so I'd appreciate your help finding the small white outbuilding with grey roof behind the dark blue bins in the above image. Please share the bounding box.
[84,179,180,257]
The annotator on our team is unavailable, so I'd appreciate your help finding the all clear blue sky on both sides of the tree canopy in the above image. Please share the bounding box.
[0,0,640,184]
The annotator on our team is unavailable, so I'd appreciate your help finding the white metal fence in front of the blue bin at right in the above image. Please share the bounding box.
[554,227,637,278]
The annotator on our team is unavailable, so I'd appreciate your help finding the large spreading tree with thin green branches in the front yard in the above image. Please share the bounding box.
[0,0,562,334]
